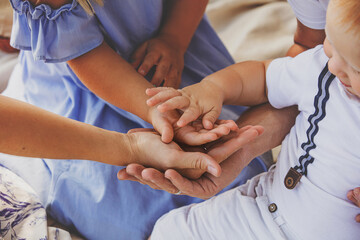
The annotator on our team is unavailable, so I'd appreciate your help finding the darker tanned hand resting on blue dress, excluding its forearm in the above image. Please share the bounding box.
[131,36,184,88]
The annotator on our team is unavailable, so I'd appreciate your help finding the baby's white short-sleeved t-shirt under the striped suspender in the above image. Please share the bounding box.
[266,45,360,239]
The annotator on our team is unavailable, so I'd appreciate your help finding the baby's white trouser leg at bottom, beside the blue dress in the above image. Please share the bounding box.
[151,171,290,240]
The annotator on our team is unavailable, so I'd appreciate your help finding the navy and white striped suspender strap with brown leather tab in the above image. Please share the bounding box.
[284,64,335,189]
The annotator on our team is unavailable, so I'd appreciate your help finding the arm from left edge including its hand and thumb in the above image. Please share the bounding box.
[0,95,221,176]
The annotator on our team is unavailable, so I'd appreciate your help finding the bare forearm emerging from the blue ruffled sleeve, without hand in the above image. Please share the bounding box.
[68,43,153,122]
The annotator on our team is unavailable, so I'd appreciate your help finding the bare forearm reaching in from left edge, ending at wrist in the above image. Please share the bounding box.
[0,96,131,165]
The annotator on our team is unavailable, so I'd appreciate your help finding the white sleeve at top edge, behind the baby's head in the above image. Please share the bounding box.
[288,0,330,29]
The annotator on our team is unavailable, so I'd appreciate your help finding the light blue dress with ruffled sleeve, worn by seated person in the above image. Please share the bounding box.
[0,0,265,240]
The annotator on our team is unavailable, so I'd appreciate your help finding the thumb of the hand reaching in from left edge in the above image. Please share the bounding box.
[176,152,221,177]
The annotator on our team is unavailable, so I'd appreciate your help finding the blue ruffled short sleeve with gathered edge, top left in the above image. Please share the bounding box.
[10,0,104,62]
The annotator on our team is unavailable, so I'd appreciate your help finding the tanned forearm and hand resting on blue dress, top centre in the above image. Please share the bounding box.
[132,0,208,88]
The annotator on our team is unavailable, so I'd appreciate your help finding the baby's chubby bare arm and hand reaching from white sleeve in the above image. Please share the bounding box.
[146,61,270,129]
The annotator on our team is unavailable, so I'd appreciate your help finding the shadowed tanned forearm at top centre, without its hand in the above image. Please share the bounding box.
[159,0,208,53]
